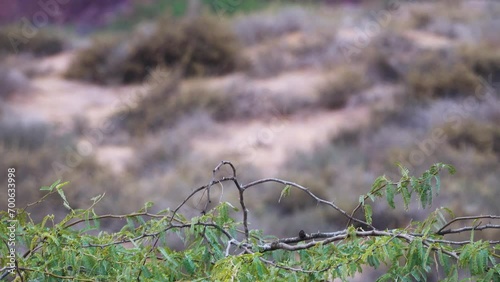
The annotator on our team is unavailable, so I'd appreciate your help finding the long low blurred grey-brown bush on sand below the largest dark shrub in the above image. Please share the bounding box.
[114,71,306,136]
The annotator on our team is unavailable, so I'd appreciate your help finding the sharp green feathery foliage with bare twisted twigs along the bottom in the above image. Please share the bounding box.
[0,162,500,281]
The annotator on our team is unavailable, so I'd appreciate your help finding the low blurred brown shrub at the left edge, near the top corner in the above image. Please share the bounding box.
[0,24,65,56]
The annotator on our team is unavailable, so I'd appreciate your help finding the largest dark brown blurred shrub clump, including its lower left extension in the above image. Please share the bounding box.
[67,14,244,83]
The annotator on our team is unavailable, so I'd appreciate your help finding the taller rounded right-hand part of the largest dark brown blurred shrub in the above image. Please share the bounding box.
[125,15,241,81]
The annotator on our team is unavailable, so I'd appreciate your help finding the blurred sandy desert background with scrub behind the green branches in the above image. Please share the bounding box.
[0,0,500,258]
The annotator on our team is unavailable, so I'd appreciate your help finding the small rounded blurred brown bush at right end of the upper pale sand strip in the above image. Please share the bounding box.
[318,67,369,109]
